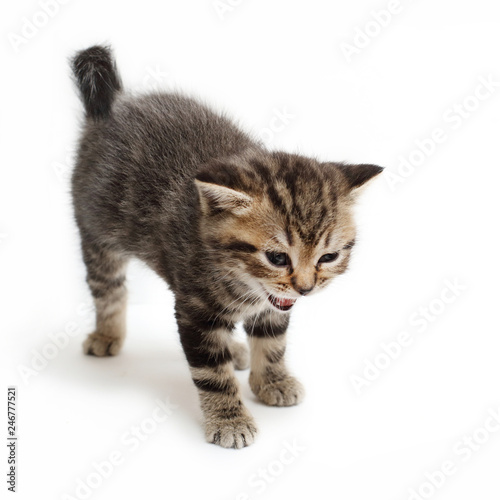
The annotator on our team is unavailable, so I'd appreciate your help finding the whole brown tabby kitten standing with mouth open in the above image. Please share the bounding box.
[72,46,382,448]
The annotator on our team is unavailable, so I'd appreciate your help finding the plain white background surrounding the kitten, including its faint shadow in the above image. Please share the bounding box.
[0,0,500,500]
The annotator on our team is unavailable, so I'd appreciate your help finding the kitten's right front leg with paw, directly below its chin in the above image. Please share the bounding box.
[244,311,304,406]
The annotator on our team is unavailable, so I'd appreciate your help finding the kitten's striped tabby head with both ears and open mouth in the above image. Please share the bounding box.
[196,153,382,311]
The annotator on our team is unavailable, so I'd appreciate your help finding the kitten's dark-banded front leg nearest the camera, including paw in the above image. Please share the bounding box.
[176,306,257,448]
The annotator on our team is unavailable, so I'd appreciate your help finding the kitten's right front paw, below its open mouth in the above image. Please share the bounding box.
[250,373,305,406]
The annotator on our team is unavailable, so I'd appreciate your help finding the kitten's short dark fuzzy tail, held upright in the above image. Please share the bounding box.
[71,45,122,120]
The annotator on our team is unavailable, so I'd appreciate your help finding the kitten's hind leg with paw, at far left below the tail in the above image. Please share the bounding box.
[82,242,127,356]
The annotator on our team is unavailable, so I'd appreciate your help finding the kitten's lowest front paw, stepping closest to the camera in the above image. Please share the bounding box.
[205,415,257,449]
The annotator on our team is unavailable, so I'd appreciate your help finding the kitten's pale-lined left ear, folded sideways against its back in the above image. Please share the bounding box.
[195,179,252,215]
